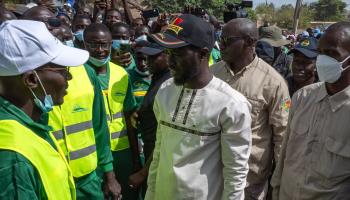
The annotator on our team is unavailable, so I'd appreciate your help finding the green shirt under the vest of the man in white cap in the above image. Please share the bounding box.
[0,97,56,200]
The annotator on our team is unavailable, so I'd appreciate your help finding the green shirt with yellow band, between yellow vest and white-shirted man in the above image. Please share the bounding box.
[128,68,151,108]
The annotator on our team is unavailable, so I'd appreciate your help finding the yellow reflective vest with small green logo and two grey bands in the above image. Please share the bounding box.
[49,66,97,177]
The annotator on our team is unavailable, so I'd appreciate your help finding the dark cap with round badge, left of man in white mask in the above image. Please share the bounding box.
[289,37,318,59]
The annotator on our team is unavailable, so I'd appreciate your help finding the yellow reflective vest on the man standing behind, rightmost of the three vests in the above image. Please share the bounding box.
[104,62,130,151]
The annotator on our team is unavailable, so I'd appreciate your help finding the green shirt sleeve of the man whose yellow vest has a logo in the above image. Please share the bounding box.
[73,65,113,188]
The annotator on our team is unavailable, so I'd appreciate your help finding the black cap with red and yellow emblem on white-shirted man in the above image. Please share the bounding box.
[151,14,215,51]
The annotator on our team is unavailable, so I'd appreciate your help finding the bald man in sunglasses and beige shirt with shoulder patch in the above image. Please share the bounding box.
[211,18,290,200]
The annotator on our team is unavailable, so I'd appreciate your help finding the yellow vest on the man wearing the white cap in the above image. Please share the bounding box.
[0,120,75,200]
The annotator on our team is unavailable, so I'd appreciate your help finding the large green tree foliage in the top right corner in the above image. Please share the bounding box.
[310,0,346,21]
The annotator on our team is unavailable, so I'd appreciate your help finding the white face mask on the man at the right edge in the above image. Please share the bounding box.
[316,54,350,83]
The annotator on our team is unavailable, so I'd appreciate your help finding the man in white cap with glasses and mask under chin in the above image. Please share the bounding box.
[0,20,89,200]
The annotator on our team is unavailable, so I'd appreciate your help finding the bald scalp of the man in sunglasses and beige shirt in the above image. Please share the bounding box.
[223,18,259,41]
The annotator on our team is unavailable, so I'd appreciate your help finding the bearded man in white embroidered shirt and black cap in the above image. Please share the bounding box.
[146,14,251,200]
